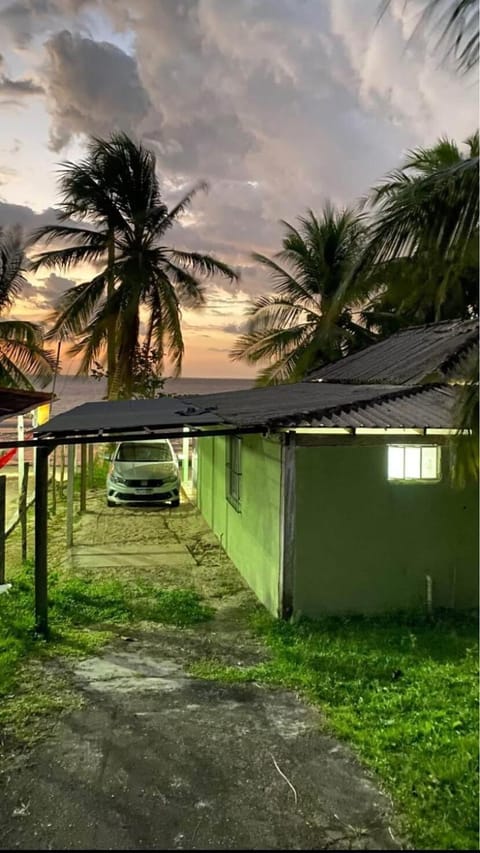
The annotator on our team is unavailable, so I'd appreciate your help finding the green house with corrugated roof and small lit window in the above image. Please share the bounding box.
[197,321,478,617]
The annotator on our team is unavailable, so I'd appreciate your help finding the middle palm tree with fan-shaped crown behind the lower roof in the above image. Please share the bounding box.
[231,204,374,385]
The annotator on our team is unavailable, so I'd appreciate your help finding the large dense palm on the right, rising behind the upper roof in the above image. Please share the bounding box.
[342,132,479,335]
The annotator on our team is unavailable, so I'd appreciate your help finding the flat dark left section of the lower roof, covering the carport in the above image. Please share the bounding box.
[35,397,221,437]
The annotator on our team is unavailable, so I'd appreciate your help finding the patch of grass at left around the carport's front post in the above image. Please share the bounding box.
[0,563,213,741]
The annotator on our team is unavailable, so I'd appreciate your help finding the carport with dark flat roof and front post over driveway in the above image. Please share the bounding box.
[0,397,264,636]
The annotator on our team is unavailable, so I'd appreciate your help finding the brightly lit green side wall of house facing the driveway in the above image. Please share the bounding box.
[198,436,281,614]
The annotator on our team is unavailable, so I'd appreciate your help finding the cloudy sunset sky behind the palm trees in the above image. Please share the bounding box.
[0,0,478,378]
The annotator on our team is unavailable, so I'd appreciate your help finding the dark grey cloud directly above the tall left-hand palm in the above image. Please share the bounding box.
[44,30,150,151]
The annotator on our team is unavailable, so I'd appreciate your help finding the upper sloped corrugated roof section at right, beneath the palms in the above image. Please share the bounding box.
[308,320,478,385]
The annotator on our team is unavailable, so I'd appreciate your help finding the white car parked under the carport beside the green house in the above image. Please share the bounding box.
[107,438,180,506]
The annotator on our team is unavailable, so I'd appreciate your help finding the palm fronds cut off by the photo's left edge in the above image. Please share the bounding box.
[0,228,54,390]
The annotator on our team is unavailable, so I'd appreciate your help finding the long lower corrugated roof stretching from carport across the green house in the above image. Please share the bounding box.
[36,382,458,441]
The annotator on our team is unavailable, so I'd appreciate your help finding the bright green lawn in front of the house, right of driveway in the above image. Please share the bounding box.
[192,614,478,850]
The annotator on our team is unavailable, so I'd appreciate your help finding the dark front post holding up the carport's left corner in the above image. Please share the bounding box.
[35,447,48,637]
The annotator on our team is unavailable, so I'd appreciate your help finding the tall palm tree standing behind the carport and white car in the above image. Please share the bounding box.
[29,134,238,397]
